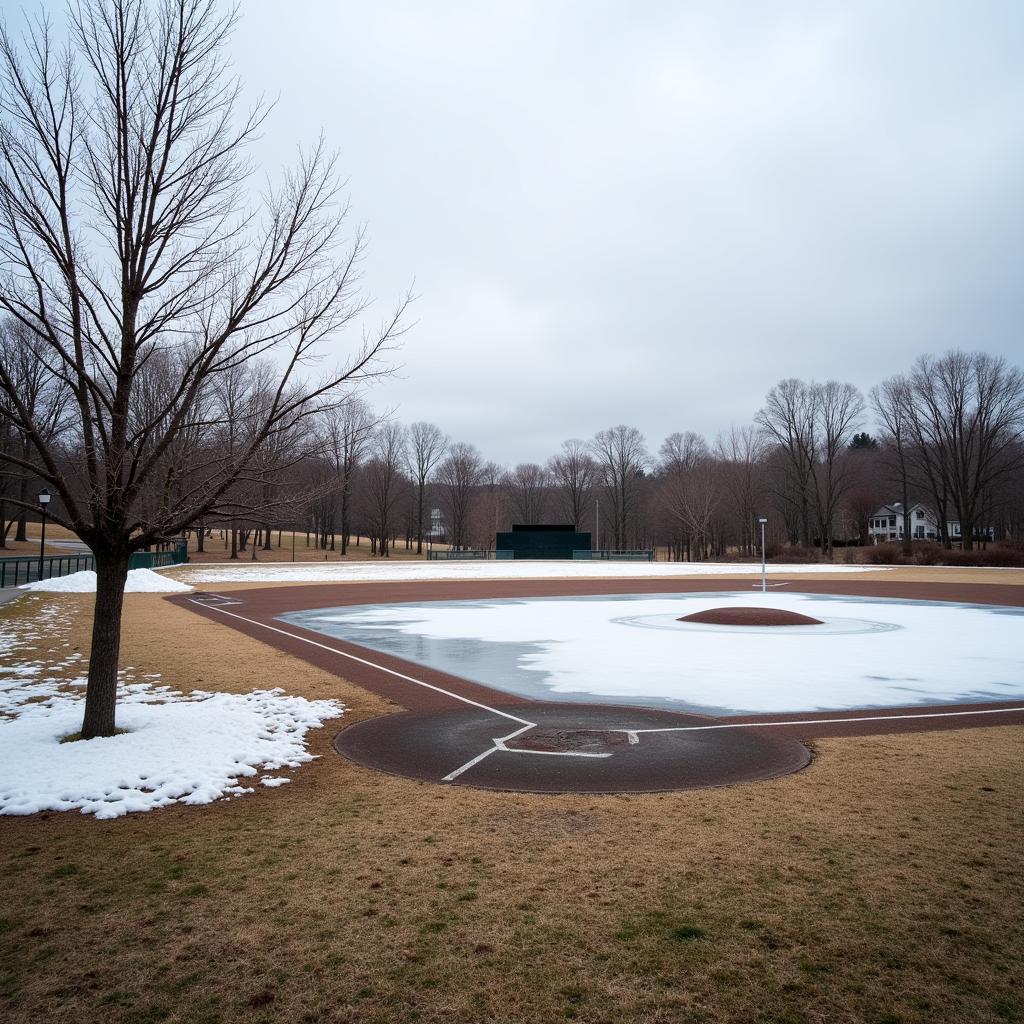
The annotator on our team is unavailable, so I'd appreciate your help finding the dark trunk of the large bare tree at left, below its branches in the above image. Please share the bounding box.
[82,551,129,739]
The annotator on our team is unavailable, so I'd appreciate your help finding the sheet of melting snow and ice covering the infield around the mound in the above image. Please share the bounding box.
[294,592,1024,714]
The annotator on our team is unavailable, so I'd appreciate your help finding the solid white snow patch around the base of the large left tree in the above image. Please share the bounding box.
[0,684,343,818]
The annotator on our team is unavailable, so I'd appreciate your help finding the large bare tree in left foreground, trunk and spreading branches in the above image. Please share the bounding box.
[0,0,404,737]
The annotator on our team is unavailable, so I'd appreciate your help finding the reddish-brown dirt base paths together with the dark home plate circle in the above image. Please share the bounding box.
[168,578,1024,793]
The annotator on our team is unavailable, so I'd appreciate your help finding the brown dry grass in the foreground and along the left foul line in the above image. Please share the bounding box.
[0,595,1024,1024]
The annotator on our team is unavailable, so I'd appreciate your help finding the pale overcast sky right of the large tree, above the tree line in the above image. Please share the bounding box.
[56,0,1024,463]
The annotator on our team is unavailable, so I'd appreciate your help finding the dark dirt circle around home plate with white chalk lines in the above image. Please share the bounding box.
[334,702,811,793]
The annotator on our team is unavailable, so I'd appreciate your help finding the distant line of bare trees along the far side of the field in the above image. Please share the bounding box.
[153,351,1024,560]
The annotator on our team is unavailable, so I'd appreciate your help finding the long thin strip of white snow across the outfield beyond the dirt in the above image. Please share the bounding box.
[179,559,892,584]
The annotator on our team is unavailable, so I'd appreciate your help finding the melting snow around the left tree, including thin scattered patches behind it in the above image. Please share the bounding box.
[0,598,343,818]
